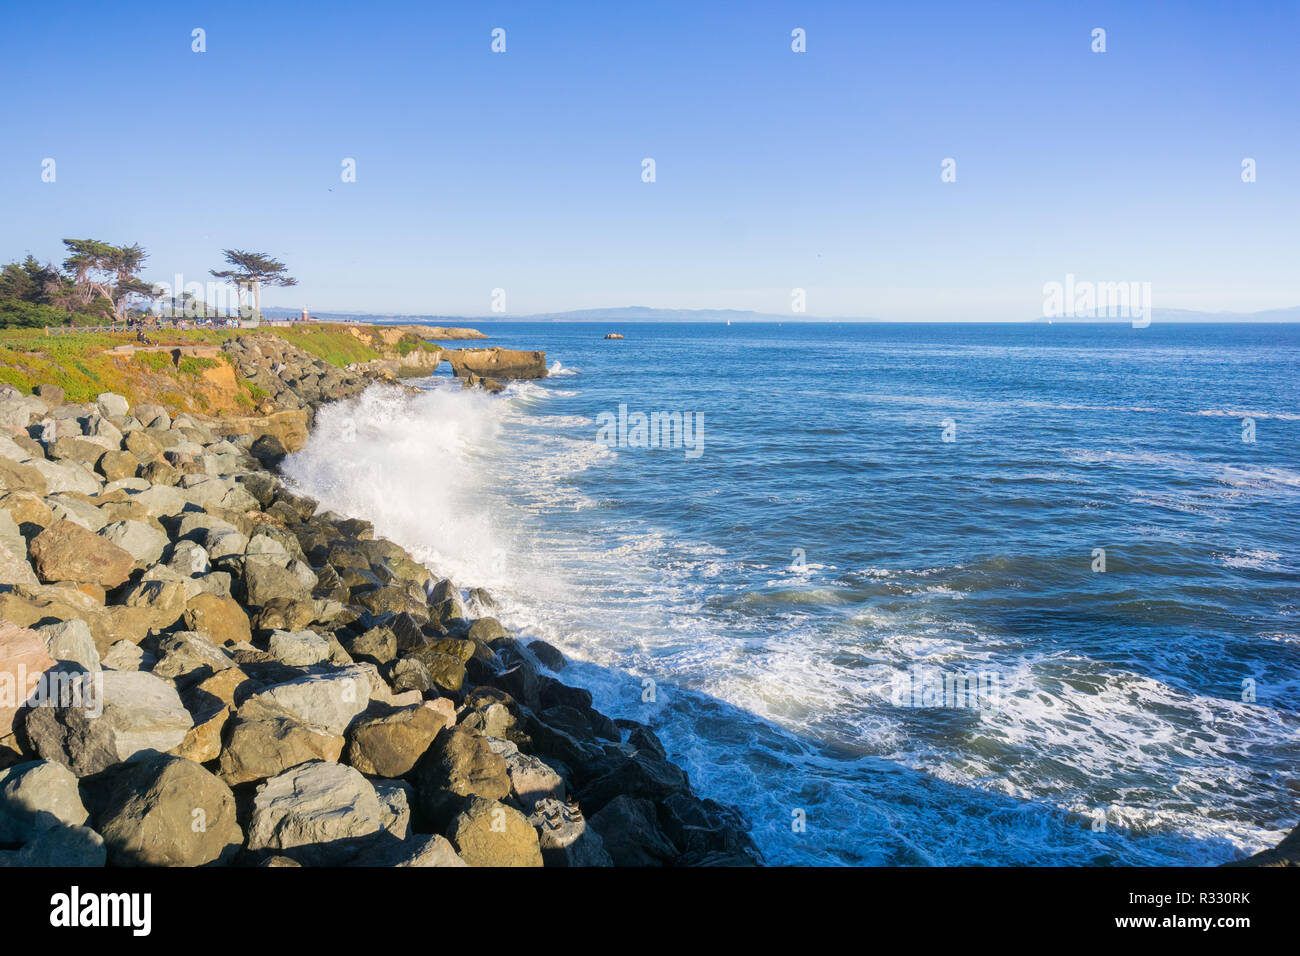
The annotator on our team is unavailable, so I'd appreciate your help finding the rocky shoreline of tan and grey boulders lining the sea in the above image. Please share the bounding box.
[0,334,762,866]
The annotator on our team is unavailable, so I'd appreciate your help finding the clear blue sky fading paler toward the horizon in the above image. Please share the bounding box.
[0,3,1300,320]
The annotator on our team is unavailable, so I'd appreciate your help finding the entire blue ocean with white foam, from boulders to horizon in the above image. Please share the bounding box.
[289,323,1300,865]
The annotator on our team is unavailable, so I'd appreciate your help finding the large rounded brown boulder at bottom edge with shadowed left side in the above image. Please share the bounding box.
[95,754,243,866]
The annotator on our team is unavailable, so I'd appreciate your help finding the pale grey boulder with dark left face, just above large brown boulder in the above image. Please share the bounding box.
[26,670,192,777]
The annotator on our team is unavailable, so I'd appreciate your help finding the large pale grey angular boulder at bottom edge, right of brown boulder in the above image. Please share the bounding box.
[248,763,384,857]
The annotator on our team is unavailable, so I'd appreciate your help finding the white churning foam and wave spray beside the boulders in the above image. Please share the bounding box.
[285,382,1300,864]
